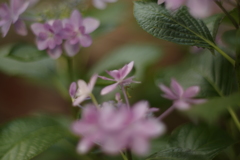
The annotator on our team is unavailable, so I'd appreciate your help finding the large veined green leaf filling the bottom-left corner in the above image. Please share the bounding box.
[0,116,71,160]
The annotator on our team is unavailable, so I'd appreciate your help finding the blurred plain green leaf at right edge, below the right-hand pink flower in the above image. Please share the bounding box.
[186,93,240,123]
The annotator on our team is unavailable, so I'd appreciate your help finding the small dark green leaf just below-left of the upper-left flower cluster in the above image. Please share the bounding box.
[8,44,48,62]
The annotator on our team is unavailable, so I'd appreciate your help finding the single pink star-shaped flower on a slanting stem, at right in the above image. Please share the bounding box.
[159,79,206,110]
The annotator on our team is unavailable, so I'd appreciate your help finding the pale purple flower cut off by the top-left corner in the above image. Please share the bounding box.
[0,0,29,37]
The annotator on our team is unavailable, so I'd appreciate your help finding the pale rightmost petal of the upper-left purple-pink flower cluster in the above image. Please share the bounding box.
[82,17,100,34]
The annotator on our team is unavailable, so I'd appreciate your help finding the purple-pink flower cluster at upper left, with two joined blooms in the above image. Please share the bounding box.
[31,10,100,59]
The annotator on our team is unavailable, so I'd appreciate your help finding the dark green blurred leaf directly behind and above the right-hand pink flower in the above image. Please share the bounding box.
[156,50,235,98]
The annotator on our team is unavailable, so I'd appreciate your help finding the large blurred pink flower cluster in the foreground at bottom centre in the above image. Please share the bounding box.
[72,101,165,155]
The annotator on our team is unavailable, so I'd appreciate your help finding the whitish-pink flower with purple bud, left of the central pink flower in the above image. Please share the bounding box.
[69,74,98,106]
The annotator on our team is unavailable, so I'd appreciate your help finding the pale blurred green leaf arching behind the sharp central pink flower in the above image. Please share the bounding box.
[90,44,162,85]
